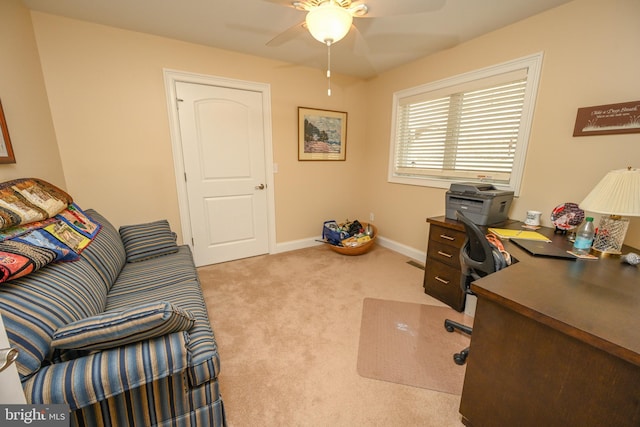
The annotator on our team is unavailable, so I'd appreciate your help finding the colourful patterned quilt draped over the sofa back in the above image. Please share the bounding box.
[0,178,100,283]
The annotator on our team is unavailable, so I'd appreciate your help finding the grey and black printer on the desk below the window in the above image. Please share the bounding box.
[445,182,513,225]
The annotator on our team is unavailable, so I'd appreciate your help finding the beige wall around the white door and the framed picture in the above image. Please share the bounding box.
[32,12,367,242]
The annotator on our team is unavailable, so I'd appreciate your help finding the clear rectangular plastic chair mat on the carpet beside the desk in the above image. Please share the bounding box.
[358,298,472,395]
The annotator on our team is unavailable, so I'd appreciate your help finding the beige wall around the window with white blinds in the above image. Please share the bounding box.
[366,0,640,251]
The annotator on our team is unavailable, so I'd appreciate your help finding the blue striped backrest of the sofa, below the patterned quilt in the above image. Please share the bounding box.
[0,209,126,380]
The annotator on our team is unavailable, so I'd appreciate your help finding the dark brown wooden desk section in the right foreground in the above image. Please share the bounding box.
[450,221,640,427]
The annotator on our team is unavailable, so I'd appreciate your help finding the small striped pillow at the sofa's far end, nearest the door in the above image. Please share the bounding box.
[120,219,178,262]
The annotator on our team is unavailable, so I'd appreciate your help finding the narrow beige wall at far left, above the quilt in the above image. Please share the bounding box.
[0,0,66,189]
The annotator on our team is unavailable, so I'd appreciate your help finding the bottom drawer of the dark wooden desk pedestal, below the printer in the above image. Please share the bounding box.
[424,259,465,311]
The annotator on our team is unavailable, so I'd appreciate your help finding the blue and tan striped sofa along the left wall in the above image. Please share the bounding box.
[0,210,226,427]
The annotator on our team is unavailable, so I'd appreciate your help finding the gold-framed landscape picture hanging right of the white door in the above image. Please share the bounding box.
[298,107,347,161]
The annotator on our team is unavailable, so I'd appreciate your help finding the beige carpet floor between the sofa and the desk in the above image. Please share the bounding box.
[198,246,462,427]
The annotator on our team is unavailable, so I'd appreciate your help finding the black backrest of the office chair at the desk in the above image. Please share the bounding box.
[456,211,507,292]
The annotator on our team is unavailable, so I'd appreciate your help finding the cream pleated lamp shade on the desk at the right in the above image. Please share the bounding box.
[580,167,640,216]
